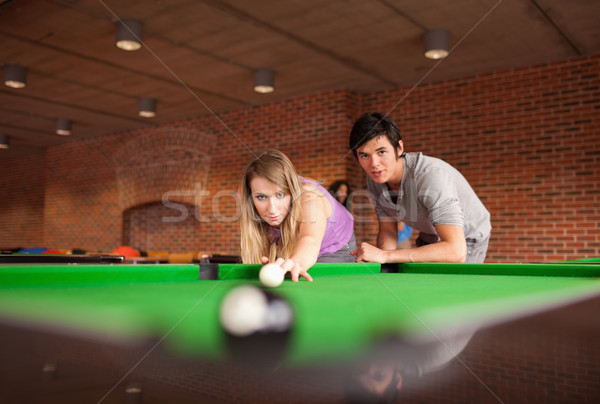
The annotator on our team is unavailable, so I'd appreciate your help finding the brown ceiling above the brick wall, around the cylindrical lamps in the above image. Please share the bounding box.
[0,0,600,160]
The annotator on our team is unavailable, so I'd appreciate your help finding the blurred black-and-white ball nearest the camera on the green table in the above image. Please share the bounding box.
[219,285,294,369]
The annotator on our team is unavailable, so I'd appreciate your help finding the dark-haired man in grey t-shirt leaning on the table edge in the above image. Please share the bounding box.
[349,113,492,263]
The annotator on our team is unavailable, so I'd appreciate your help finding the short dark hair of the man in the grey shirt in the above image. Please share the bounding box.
[348,112,402,157]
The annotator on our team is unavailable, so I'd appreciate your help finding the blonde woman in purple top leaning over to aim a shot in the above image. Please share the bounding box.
[241,150,356,282]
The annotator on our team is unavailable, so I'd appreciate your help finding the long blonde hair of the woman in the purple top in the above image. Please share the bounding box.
[240,149,302,264]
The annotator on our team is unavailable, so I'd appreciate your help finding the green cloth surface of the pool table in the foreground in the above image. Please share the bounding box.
[0,263,600,402]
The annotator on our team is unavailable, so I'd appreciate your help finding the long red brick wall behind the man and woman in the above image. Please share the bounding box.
[0,55,600,262]
